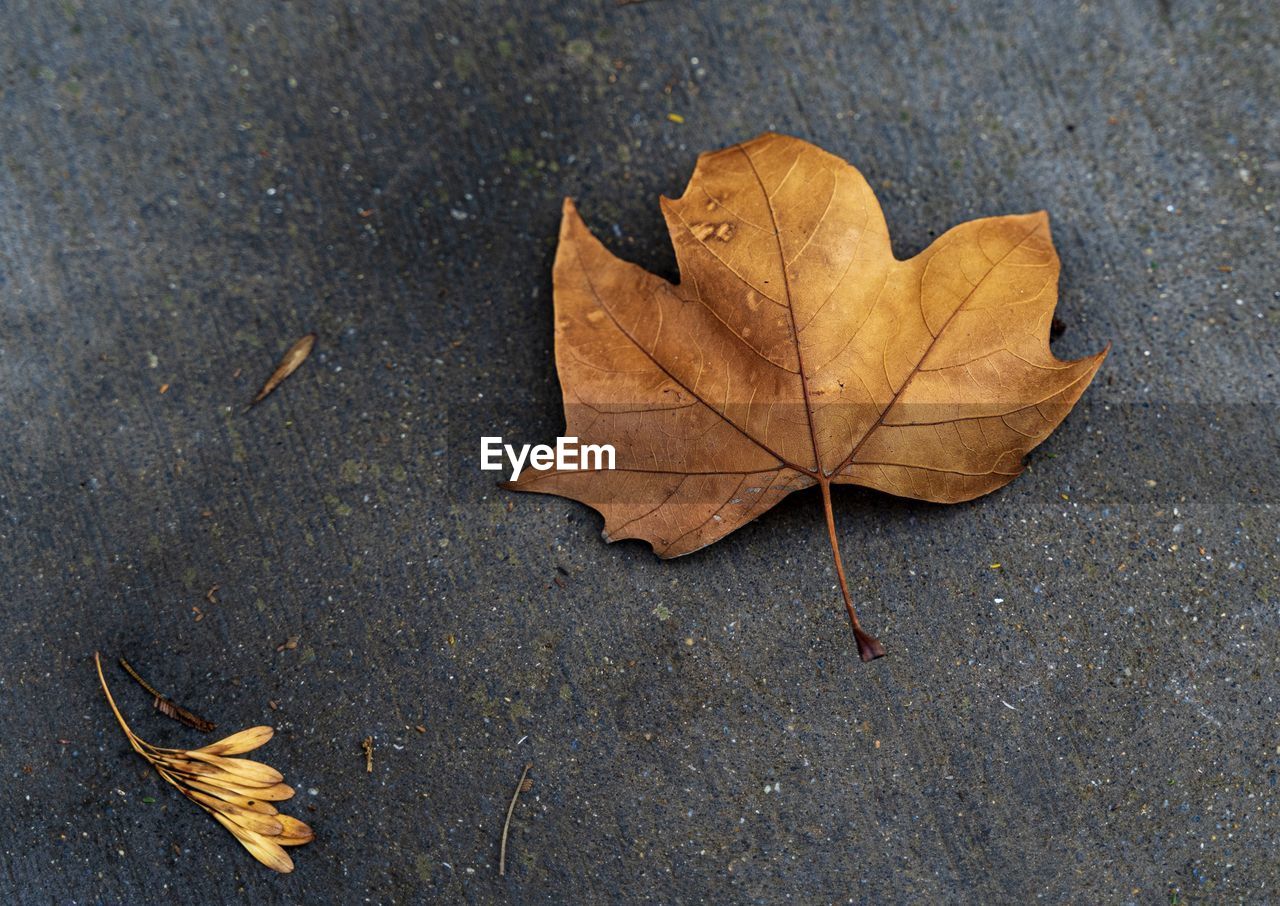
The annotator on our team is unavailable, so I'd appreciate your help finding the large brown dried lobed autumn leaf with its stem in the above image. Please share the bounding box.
[508,134,1106,660]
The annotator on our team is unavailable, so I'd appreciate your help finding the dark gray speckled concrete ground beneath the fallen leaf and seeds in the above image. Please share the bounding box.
[0,0,1280,903]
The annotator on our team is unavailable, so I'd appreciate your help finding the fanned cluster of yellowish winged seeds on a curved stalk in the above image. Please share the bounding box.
[93,651,315,871]
